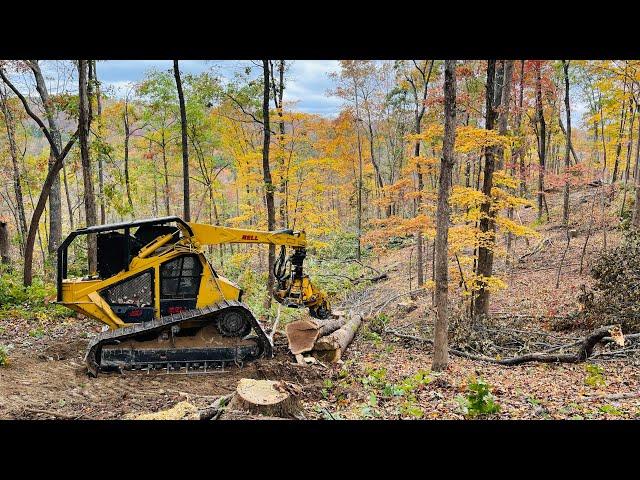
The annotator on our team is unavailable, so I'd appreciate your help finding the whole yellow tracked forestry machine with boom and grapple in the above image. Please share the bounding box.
[57,217,330,376]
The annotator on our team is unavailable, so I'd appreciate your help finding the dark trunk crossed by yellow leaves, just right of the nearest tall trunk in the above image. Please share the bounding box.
[473,60,502,317]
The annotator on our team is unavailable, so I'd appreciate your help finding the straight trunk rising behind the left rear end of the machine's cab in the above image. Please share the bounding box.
[78,60,98,275]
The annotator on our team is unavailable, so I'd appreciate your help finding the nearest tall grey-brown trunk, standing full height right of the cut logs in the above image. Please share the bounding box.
[432,60,456,371]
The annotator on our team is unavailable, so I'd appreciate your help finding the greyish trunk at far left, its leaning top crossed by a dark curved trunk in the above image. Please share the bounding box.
[28,60,62,254]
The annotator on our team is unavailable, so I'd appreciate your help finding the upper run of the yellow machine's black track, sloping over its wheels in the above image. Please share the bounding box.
[84,300,273,377]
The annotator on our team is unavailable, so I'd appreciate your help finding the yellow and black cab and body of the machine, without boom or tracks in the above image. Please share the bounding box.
[58,217,232,328]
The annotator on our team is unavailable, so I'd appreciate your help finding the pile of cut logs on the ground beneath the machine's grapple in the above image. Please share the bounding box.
[285,312,362,362]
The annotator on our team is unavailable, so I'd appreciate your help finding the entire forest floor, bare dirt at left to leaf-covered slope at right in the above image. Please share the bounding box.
[0,188,640,419]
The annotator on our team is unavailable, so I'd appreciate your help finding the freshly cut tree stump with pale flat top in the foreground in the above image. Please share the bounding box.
[229,378,300,418]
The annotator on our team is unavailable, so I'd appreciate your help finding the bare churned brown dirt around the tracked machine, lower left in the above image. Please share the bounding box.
[0,319,321,419]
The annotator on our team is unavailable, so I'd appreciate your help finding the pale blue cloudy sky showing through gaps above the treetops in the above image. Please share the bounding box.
[97,60,342,116]
